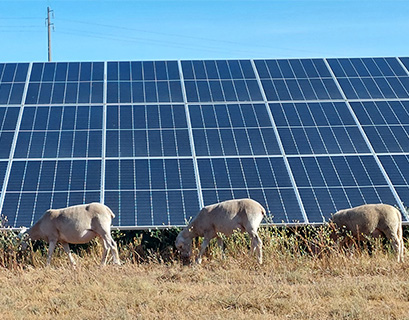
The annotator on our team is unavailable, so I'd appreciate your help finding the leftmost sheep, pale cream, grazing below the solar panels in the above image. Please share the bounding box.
[19,203,120,267]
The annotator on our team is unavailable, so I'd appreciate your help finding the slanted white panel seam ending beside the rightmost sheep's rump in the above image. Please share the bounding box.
[324,59,409,220]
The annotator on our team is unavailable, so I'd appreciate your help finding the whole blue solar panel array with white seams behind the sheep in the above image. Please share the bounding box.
[0,58,409,229]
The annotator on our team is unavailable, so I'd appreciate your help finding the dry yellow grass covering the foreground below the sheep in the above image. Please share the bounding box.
[0,226,409,320]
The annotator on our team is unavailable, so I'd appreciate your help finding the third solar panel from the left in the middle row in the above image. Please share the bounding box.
[106,105,191,157]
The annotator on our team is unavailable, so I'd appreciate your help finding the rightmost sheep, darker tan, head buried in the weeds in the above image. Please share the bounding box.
[331,204,404,262]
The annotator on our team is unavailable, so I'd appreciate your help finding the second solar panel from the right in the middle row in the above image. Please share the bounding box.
[270,102,369,155]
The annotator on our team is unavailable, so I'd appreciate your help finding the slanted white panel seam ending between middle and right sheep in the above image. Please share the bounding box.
[250,59,309,224]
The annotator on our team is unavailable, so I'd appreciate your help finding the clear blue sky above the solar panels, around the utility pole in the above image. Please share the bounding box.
[0,0,409,62]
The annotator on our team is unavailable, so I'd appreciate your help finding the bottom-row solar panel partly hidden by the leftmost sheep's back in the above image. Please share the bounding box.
[2,160,101,226]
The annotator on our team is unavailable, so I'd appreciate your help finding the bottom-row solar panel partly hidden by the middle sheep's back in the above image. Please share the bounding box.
[198,157,304,223]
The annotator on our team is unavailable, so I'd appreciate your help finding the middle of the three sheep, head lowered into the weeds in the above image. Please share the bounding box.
[175,199,266,264]
